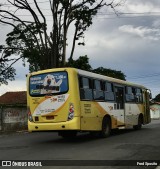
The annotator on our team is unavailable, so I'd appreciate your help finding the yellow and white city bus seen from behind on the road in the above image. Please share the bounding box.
[27,68,151,137]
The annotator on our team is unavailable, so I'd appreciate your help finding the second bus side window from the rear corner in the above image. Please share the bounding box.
[93,80,104,100]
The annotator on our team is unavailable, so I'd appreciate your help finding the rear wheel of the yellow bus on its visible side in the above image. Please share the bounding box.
[99,117,111,138]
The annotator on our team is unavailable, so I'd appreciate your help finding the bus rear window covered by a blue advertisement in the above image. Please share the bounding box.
[29,72,68,96]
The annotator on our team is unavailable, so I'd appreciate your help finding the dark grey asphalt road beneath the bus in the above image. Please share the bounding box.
[0,120,160,169]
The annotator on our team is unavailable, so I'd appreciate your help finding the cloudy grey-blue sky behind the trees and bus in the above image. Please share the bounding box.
[0,0,160,97]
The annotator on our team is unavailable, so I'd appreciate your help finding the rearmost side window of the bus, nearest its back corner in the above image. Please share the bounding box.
[79,77,93,100]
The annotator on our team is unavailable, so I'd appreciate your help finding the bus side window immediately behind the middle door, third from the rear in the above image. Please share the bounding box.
[104,82,115,101]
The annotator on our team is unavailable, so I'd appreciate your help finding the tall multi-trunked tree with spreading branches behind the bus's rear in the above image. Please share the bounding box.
[0,0,121,70]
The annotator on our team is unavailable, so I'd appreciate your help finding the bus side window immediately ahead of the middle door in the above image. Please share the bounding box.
[126,86,136,102]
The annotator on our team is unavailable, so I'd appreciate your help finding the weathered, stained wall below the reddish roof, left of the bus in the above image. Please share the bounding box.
[0,105,27,131]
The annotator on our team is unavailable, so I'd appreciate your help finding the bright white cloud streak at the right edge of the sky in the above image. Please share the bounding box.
[119,25,160,41]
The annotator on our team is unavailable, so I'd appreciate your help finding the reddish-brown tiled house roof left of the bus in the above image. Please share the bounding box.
[0,91,27,105]
